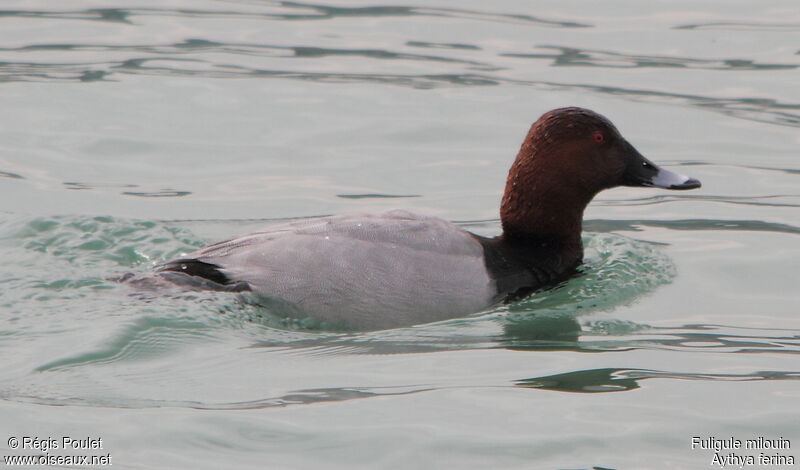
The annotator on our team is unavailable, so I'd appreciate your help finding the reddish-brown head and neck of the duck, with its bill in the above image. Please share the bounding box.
[500,107,700,242]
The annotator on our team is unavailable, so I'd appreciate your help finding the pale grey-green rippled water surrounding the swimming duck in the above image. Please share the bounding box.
[0,0,800,469]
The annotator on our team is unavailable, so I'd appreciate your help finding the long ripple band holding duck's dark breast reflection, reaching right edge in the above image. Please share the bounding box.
[244,320,800,355]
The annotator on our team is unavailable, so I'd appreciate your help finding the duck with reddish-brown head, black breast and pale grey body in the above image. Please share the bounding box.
[147,107,701,330]
